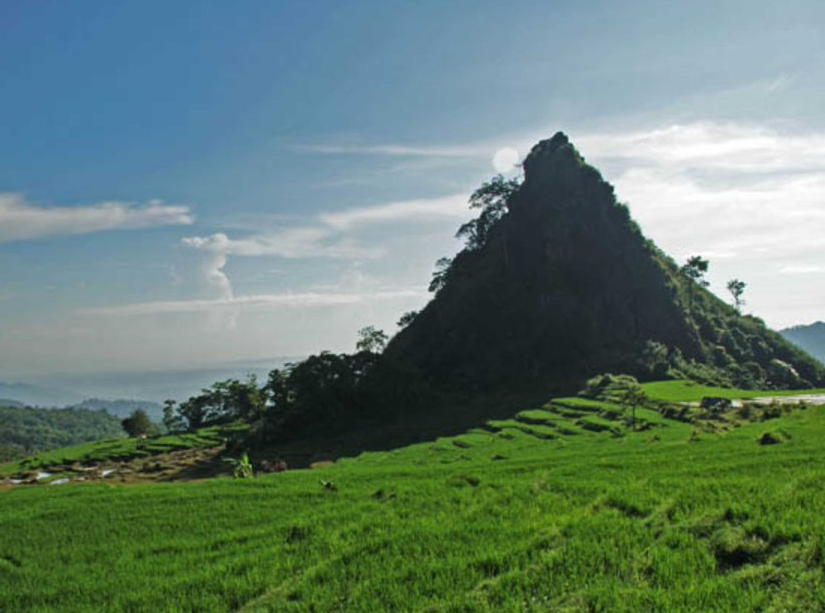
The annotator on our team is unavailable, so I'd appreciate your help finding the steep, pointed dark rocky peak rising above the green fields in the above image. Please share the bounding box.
[385,133,825,391]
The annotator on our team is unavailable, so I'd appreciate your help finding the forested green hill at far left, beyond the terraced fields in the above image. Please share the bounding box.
[0,407,125,457]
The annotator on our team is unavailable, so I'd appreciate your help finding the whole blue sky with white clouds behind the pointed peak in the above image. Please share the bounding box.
[0,0,825,379]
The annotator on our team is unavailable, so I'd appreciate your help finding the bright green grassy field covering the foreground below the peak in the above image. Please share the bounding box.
[0,384,825,613]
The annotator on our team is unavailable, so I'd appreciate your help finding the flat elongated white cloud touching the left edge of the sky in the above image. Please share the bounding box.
[0,193,193,243]
